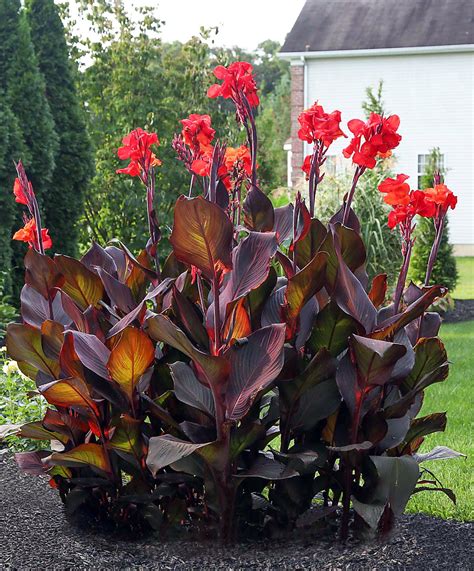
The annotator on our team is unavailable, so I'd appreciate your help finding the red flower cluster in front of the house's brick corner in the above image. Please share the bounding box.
[298,102,347,147]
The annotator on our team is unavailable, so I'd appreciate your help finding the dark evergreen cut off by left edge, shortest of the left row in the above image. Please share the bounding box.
[0,90,26,296]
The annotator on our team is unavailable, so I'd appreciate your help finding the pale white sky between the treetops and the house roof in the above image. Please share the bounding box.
[65,0,305,50]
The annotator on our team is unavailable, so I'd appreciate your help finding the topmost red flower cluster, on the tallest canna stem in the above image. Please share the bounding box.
[207,61,260,107]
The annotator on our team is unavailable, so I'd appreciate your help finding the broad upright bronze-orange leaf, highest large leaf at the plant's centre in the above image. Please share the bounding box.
[170,196,233,280]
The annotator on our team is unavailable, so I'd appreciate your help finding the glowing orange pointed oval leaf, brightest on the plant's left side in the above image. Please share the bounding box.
[107,327,155,399]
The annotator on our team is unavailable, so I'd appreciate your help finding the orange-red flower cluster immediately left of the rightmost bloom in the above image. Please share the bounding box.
[378,174,436,230]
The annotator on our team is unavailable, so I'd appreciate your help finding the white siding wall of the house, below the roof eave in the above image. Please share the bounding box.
[306,52,474,244]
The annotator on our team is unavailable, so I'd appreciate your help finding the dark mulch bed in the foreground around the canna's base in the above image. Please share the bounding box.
[0,451,474,571]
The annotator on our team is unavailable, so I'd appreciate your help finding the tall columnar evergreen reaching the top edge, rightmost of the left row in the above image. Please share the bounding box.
[26,0,93,255]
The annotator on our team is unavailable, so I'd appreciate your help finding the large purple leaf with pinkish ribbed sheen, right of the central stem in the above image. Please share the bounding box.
[225,324,285,420]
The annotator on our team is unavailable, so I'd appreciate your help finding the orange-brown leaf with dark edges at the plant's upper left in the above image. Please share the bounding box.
[54,254,104,310]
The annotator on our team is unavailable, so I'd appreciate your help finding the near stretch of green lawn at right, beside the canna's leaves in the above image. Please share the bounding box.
[408,322,474,520]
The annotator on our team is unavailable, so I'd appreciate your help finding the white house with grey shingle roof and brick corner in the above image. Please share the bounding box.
[280,0,474,255]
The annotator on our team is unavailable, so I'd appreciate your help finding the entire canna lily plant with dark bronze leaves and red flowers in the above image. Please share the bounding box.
[7,62,459,542]
